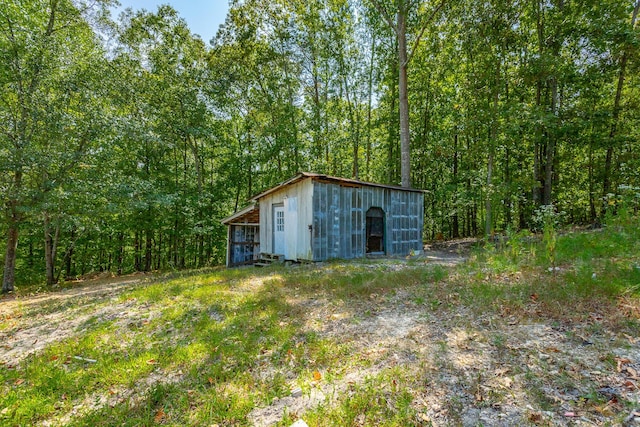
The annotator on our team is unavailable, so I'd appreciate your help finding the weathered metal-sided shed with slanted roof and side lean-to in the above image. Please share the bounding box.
[222,172,424,266]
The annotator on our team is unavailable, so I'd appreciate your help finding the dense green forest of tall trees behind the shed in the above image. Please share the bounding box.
[0,0,640,292]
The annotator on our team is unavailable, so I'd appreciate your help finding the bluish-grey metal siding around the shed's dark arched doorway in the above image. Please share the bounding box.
[312,181,424,261]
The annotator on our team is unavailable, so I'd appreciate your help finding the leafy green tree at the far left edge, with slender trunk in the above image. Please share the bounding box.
[0,0,111,292]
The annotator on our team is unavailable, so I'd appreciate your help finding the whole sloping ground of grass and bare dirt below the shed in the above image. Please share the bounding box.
[0,218,640,426]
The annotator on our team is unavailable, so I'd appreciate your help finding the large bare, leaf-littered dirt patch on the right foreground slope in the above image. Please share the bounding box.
[249,292,640,426]
